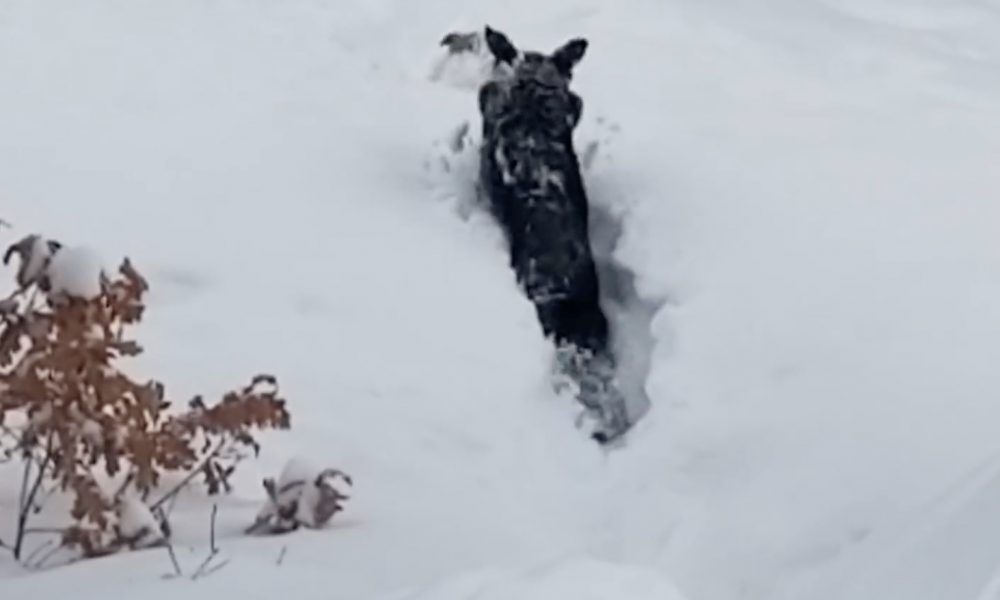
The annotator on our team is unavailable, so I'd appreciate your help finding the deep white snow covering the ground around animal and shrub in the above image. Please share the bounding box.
[0,0,1000,600]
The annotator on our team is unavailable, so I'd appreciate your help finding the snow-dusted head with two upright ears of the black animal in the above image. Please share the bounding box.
[479,26,587,132]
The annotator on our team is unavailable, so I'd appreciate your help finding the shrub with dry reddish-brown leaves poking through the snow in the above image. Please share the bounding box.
[0,236,290,559]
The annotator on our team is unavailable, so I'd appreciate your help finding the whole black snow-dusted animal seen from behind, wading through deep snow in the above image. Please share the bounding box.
[479,27,627,439]
